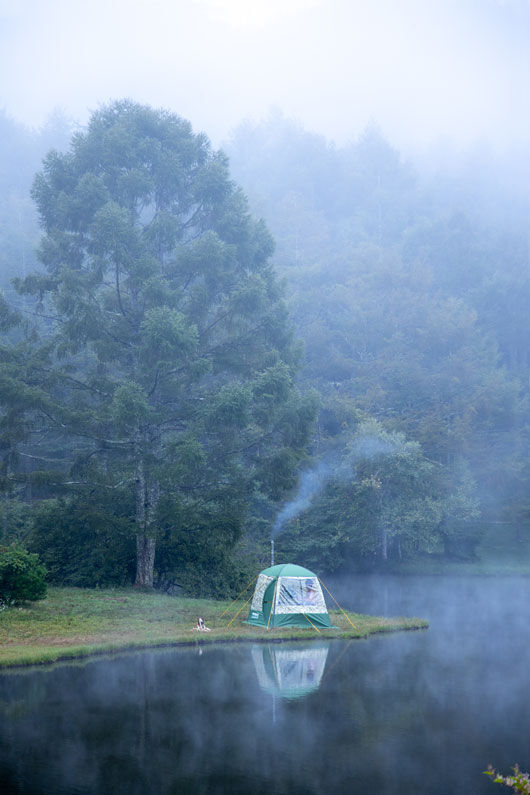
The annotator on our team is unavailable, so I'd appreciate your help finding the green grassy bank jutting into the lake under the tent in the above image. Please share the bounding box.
[0,588,427,666]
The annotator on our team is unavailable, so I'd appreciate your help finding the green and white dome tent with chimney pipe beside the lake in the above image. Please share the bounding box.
[247,563,331,628]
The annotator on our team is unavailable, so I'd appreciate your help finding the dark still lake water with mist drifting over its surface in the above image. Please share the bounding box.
[0,577,530,795]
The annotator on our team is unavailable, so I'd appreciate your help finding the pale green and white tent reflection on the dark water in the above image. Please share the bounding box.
[252,641,329,699]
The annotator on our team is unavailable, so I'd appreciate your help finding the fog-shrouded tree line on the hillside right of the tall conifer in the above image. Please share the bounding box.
[228,114,530,567]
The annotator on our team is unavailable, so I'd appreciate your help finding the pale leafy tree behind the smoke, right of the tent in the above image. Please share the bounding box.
[278,419,478,571]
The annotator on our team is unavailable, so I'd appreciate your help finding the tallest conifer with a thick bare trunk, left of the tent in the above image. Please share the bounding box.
[19,100,314,586]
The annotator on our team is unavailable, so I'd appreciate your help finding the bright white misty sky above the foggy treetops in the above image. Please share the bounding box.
[0,0,530,147]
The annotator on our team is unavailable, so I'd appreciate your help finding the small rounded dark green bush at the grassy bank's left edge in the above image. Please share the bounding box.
[0,544,46,604]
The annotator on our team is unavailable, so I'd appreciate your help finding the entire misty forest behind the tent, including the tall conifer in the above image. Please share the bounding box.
[0,100,530,596]
